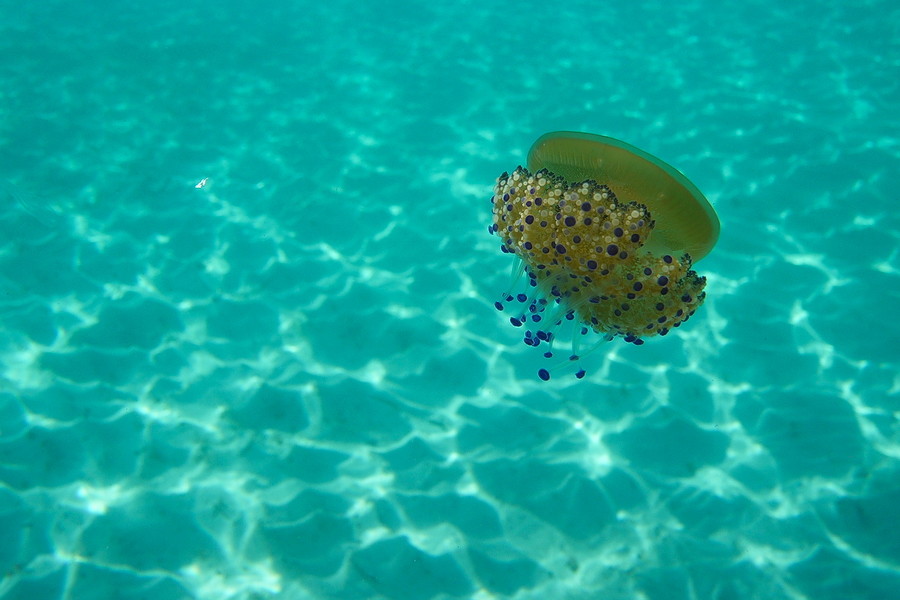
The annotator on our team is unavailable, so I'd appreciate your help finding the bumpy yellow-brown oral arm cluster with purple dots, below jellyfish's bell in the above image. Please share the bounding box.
[494,167,706,341]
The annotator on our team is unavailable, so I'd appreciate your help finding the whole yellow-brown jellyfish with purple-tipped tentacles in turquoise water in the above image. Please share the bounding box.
[489,132,719,380]
